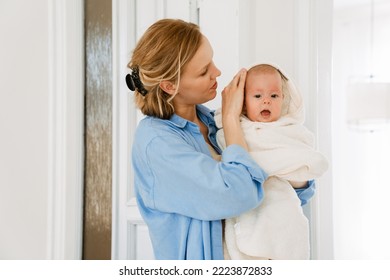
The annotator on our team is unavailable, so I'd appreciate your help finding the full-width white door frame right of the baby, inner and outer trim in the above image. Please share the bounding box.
[294,0,333,259]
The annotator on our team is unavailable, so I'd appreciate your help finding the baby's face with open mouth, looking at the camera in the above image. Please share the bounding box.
[245,72,283,122]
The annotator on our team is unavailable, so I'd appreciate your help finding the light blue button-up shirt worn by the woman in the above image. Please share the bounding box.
[132,106,314,260]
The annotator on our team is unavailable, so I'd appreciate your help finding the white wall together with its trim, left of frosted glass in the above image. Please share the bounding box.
[0,0,83,259]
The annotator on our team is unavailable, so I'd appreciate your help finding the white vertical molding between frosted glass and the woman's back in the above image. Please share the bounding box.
[111,0,137,259]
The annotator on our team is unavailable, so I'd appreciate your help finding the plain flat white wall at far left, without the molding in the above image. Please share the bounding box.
[0,0,49,259]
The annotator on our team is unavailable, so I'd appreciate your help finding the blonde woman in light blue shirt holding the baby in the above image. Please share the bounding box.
[126,19,313,259]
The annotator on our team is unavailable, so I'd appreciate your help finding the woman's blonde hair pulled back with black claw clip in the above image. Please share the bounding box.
[127,19,202,119]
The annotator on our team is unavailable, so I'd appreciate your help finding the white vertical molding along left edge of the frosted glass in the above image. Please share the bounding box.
[47,0,84,259]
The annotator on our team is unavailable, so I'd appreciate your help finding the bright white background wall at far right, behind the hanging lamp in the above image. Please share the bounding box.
[332,0,390,260]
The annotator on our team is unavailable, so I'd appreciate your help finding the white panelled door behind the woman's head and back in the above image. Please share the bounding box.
[112,0,239,260]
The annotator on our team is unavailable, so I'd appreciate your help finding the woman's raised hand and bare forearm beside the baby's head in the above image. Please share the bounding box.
[222,69,248,150]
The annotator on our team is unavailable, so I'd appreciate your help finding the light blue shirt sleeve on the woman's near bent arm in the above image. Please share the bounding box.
[135,136,267,220]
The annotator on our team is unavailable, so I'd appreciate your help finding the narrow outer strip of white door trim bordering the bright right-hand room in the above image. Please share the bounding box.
[311,0,334,259]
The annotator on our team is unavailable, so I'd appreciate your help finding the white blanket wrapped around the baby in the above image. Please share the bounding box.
[215,64,328,260]
